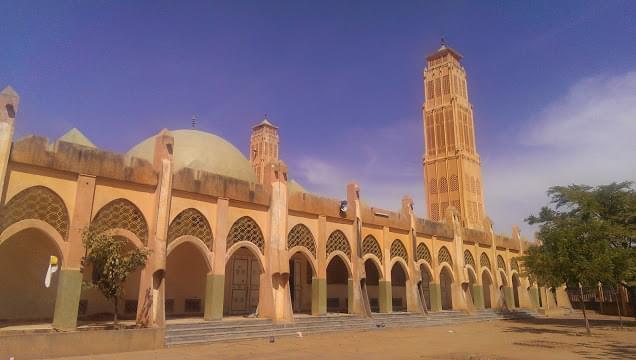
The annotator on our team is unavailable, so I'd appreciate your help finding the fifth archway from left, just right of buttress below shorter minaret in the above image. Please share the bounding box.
[289,251,316,314]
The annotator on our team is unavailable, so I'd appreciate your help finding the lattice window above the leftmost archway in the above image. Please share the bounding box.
[0,186,70,240]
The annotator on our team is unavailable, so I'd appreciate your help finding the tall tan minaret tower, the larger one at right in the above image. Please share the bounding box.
[422,40,485,228]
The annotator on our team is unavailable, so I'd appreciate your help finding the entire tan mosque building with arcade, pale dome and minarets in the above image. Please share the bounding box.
[0,45,545,329]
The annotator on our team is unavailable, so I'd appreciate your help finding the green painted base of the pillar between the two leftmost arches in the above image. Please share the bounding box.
[53,269,83,330]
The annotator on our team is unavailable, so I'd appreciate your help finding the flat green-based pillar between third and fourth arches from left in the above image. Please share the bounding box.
[203,198,230,320]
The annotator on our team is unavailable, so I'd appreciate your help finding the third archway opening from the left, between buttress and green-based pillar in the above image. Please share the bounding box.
[165,240,211,317]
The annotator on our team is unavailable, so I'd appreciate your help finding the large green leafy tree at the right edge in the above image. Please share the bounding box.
[522,182,636,334]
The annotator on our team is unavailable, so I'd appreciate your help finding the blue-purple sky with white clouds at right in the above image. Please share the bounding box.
[0,0,636,237]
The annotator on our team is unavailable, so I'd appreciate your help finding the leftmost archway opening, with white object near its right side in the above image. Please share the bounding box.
[0,228,63,324]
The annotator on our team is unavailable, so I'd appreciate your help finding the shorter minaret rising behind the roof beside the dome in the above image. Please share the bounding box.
[250,115,278,184]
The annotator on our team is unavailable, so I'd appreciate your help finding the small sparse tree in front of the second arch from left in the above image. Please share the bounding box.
[82,229,150,326]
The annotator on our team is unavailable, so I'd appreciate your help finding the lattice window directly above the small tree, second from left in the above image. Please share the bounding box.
[91,199,148,244]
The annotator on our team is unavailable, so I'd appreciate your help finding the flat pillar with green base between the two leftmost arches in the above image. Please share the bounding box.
[53,175,95,330]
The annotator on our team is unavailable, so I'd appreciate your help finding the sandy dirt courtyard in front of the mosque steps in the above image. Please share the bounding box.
[63,314,636,360]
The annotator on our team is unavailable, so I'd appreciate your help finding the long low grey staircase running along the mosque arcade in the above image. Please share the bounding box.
[166,309,541,346]
